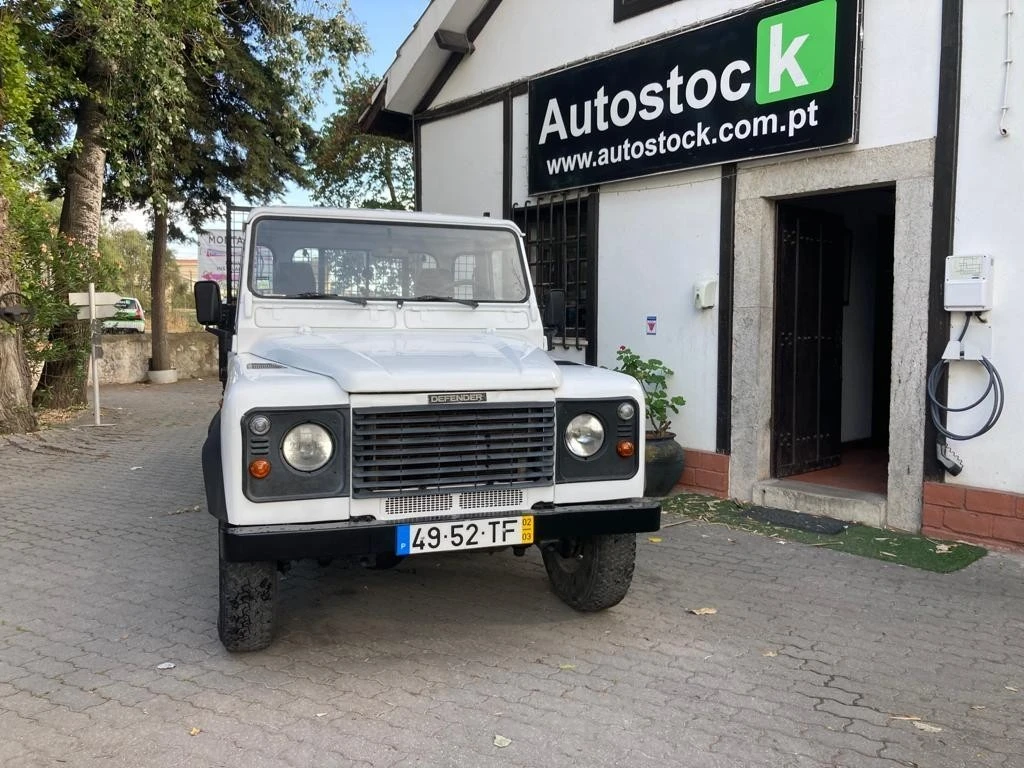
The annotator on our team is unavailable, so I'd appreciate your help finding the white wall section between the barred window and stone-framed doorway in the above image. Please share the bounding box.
[597,168,721,451]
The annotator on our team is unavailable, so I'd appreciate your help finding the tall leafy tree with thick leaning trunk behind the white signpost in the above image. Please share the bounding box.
[14,0,226,406]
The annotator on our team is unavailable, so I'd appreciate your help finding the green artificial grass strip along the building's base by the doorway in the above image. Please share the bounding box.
[662,494,987,573]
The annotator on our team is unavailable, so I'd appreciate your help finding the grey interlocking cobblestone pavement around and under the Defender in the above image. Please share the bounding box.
[0,382,1024,768]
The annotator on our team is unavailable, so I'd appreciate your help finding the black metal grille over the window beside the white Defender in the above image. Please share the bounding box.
[512,195,595,350]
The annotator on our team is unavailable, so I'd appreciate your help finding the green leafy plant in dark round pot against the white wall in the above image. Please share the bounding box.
[615,346,686,496]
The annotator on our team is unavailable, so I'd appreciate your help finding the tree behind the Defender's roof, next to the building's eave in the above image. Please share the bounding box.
[312,75,414,210]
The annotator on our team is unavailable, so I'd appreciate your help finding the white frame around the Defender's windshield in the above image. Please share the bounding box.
[246,213,534,306]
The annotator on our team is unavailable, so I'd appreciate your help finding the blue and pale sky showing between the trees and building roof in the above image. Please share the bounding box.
[111,0,429,259]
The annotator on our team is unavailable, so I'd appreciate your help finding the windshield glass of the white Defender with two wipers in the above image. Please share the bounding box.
[248,218,527,304]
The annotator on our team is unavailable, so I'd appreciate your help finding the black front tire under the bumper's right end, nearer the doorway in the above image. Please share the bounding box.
[542,534,637,611]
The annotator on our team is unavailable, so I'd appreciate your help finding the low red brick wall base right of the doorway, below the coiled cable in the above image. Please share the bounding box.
[921,482,1024,549]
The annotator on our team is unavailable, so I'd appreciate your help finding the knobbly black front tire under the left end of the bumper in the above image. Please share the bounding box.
[217,556,278,652]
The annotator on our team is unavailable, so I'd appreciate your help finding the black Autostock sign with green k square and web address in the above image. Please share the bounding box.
[529,0,859,195]
